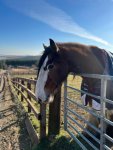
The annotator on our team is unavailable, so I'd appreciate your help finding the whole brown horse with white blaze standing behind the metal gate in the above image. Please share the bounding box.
[36,39,113,146]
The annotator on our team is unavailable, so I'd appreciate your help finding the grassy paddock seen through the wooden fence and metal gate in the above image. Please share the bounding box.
[10,70,96,150]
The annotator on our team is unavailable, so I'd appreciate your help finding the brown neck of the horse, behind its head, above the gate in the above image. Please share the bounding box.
[59,45,104,74]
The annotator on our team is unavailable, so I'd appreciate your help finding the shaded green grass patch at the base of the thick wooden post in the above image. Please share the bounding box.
[33,131,81,150]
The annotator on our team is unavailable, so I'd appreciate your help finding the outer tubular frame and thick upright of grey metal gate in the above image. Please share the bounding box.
[64,73,113,150]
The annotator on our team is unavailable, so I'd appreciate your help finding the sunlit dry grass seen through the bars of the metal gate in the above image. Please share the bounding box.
[61,75,88,135]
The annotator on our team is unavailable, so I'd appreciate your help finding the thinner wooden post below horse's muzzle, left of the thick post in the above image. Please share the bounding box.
[40,104,46,139]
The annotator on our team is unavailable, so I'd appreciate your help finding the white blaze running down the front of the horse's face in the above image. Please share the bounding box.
[35,57,49,102]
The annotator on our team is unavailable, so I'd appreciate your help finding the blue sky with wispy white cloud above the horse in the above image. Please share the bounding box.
[0,0,113,55]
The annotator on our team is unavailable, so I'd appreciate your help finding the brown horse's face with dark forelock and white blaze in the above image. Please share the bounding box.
[36,41,68,103]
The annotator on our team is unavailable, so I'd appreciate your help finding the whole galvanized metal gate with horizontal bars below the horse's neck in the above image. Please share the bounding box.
[64,74,113,150]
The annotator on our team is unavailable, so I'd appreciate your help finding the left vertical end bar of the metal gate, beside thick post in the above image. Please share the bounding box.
[64,79,67,130]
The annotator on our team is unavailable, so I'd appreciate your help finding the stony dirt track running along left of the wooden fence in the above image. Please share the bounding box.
[0,77,31,150]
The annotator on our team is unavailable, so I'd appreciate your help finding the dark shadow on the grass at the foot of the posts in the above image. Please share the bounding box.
[33,133,99,150]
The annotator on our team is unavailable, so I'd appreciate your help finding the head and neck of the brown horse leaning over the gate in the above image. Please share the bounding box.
[36,40,111,102]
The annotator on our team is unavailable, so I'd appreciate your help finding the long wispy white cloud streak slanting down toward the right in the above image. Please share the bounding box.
[3,0,111,46]
